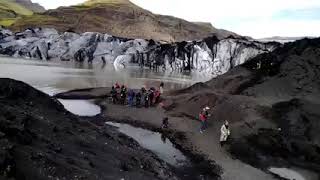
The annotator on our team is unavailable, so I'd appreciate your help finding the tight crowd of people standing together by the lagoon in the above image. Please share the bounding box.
[110,82,164,108]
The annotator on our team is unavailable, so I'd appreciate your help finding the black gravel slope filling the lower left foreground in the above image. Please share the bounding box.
[0,78,183,180]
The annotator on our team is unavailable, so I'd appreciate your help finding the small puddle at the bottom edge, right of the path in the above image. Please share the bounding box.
[268,167,319,180]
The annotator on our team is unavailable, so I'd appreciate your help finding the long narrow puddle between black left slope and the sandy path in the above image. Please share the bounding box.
[106,122,189,167]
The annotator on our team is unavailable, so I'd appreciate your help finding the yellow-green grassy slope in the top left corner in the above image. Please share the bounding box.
[0,0,45,26]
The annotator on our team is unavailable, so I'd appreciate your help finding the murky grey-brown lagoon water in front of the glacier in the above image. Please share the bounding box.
[0,57,210,93]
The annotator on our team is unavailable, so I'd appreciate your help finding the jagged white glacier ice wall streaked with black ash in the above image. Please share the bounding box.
[0,28,279,75]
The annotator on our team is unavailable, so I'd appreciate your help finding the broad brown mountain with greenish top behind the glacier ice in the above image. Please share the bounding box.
[11,0,238,42]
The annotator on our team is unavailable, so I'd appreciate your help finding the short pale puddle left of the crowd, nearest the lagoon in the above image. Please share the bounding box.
[58,99,101,116]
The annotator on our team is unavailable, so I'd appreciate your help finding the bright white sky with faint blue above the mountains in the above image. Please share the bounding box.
[32,0,320,38]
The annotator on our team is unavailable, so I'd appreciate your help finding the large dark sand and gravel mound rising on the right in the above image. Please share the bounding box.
[165,38,320,172]
